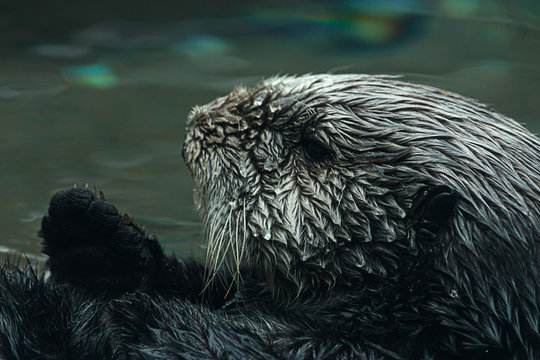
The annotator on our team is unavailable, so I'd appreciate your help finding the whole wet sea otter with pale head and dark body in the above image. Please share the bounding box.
[0,75,540,359]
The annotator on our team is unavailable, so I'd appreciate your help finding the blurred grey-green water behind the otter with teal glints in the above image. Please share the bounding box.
[0,0,540,259]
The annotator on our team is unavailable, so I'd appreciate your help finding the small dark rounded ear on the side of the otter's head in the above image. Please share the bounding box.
[407,185,457,239]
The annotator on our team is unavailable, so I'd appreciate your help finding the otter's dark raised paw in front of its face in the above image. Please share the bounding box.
[39,188,155,290]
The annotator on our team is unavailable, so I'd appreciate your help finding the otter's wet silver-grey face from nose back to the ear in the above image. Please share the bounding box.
[184,75,540,291]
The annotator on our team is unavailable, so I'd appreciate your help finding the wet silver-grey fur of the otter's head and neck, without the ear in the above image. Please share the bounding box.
[184,75,540,356]
